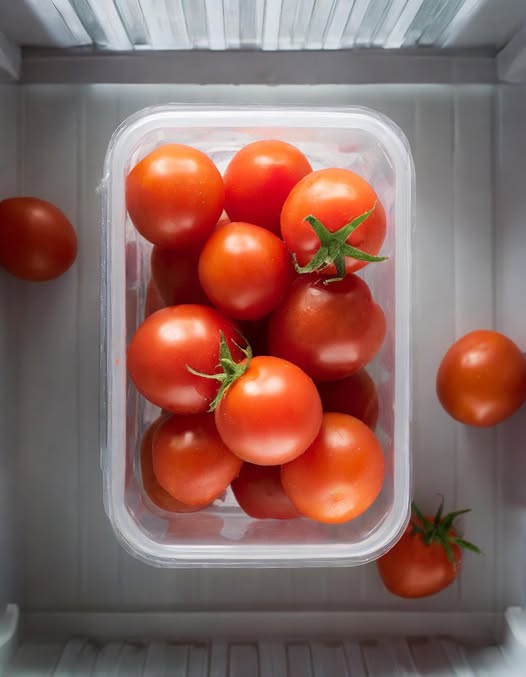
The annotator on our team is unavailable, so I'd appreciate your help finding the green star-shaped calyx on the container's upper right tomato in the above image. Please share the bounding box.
[292,202,388,284]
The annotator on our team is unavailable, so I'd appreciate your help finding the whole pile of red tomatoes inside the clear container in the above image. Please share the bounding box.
[126,141,392,524]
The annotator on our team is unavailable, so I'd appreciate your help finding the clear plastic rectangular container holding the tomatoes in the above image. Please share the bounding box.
[101,105,414,567]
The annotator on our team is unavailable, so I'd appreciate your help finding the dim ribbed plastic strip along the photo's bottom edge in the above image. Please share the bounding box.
[6,638,519,677]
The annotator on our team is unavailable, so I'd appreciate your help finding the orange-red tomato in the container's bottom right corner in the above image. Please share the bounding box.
[281,413,385,524]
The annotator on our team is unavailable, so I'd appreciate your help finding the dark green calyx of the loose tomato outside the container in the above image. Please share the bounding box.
[411,499,482,569]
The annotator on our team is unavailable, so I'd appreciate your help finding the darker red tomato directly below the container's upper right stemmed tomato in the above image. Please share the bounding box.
[268,275,385,381]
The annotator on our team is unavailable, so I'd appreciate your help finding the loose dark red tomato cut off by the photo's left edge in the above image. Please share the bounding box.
[0,197,77,282]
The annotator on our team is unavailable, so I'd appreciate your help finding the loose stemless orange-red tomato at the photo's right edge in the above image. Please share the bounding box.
[436,329,526,427]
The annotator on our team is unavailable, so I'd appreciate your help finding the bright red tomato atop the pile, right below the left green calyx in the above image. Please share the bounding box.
[215,357,322,465]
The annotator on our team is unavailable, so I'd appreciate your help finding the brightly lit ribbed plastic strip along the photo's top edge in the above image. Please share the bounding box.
[7,0,521,51]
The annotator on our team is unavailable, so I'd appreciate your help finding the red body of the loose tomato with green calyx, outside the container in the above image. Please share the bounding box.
[377,517,462,599]
